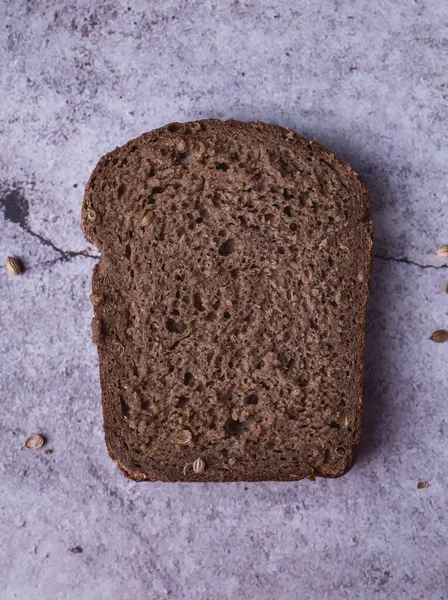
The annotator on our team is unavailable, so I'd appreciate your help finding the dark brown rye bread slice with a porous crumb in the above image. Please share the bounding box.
[82,119,373,481]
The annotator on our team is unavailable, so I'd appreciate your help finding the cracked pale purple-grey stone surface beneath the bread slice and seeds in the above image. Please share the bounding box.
[0,0,448,600]
